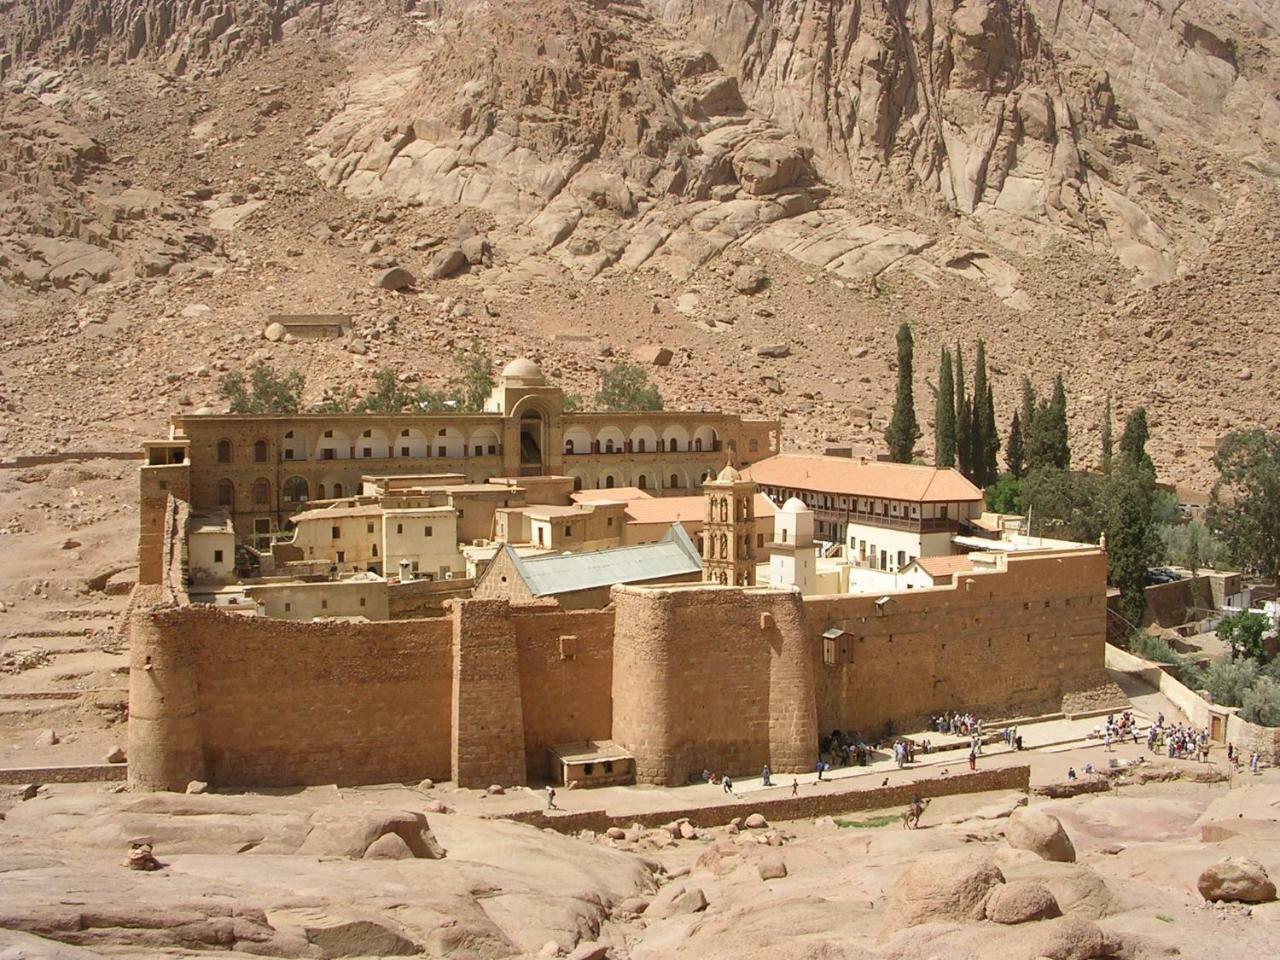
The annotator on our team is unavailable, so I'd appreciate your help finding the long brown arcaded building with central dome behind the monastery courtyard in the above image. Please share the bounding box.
[142,358,781,555]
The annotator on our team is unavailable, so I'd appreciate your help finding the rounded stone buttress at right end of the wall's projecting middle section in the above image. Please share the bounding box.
[768,590,818,773]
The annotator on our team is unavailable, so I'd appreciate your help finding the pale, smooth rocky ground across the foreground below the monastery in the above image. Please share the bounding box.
[0,774,1280,960]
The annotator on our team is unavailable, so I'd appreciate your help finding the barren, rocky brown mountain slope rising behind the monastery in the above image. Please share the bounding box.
[0,0,1280,480]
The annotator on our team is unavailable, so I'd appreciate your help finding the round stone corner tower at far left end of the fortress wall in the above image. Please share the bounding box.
[128,599,206,791]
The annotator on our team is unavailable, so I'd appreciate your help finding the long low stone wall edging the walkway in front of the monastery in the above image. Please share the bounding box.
[493,767,1032,833]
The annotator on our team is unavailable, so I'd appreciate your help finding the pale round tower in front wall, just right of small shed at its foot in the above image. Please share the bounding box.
[613,586,676,785]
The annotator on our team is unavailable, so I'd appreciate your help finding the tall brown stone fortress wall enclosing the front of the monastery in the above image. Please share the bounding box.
[129,500,1105,790]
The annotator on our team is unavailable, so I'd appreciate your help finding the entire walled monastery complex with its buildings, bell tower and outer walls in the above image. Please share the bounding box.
[129,360,1114,790]
